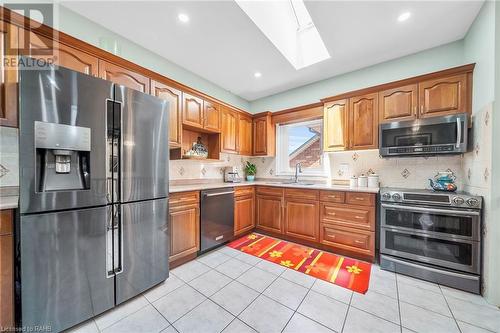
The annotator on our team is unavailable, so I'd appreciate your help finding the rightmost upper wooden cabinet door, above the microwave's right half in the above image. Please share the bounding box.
[418,74,470,118]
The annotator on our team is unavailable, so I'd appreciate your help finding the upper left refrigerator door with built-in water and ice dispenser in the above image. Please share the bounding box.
[19,67,113,213]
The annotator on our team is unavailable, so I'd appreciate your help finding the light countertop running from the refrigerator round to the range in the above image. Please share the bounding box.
[169,180,379,193]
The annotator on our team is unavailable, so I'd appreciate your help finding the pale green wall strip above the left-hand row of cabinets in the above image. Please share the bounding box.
[55,6,250,110]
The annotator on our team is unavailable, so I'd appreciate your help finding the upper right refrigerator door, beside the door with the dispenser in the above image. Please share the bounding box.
[115,85,169,202]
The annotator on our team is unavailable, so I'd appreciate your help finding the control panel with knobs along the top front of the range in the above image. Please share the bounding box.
[380,188,482,209]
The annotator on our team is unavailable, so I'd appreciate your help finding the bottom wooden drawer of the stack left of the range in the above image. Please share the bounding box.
[320,223,375,255]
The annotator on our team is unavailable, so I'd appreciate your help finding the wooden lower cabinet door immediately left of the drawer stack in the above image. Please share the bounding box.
[285,199,319,241]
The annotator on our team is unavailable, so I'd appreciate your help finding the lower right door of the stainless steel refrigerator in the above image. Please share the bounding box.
[115,198,169,304]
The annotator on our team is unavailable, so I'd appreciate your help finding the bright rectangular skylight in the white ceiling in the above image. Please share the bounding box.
[235,0,330,70]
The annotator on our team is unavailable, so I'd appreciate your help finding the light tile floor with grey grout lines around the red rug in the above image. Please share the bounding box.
[66,247,500,333]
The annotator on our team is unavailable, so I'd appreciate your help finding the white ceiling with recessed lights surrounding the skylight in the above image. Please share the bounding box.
[60,0,483,101]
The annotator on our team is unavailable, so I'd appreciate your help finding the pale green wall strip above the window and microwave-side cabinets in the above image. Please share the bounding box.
[250,41,465,113]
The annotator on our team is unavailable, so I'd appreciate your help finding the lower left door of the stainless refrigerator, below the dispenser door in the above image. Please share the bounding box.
[20,207,114,332]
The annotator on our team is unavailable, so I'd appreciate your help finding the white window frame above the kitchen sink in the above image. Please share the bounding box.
[276,119,328,177]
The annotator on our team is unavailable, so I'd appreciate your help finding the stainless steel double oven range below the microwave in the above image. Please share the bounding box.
[380,188,482,294]
